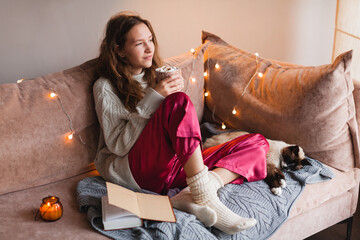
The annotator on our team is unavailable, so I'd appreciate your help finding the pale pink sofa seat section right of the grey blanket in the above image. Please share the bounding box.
[289,166,359,218]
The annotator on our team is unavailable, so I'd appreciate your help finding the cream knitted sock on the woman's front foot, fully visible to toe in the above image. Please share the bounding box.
[186,166,256,234]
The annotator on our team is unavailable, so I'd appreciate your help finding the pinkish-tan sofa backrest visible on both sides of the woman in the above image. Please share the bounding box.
[0,44,207,195]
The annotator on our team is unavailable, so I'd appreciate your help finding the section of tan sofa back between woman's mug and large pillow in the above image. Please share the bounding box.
[165,43,208,121]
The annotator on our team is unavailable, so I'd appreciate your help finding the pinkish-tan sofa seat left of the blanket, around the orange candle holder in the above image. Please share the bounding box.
[0,171,108,239]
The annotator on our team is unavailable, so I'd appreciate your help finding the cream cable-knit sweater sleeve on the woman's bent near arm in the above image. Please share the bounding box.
[93,78,164,157]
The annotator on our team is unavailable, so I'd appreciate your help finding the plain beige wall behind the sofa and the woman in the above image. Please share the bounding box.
[0,0,336,83]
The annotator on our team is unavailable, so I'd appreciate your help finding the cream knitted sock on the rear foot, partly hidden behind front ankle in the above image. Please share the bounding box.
[170,172,224,227]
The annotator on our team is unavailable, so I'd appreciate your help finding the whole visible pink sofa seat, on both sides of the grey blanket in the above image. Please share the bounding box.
[0,168,356,239]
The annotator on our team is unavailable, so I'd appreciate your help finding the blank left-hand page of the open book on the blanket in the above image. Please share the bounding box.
[106,182,141,217]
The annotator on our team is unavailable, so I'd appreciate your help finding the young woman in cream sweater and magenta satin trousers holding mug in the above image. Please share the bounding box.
[93,12,268,234]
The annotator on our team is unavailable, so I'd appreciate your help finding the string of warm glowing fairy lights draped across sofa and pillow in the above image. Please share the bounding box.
[17,48,263,145]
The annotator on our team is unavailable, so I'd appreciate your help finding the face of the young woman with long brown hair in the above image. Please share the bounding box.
[120,23,155,74]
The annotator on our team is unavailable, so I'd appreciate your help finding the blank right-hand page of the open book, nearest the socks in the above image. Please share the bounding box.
[136,193,176,222]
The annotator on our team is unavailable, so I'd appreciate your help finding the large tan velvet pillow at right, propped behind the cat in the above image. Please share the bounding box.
[202,32,359,171]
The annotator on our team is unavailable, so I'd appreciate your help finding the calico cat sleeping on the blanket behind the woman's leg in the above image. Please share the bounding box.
[203,131,307,196]
